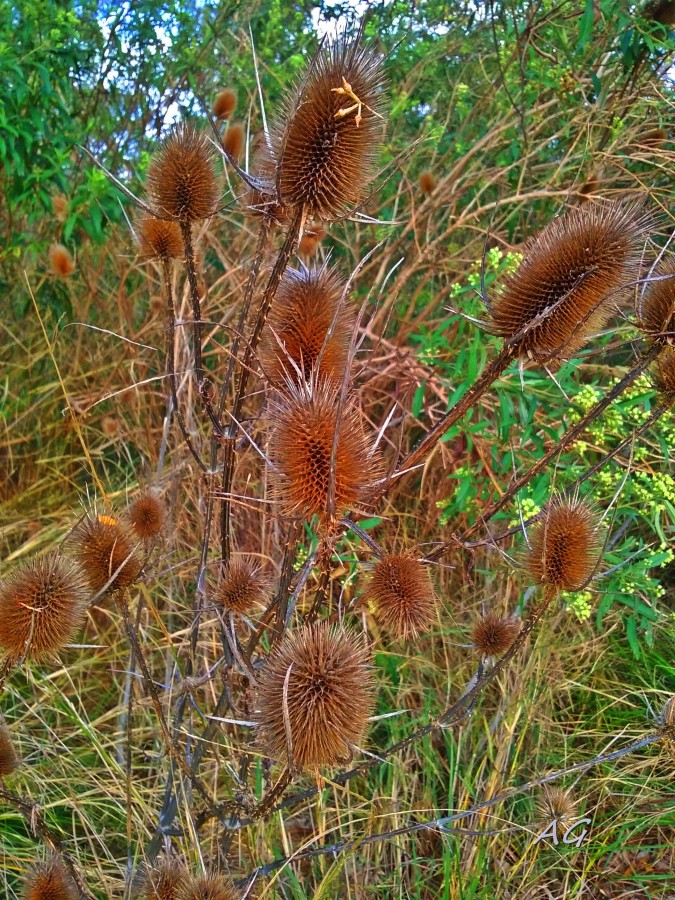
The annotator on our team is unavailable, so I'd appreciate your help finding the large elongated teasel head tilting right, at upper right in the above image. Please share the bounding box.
[492,202,654,362]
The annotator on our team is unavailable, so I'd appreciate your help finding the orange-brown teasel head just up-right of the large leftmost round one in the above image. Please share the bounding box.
[70,513,143,594]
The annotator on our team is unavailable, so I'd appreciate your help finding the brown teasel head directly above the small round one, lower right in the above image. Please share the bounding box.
[525,499,601,594]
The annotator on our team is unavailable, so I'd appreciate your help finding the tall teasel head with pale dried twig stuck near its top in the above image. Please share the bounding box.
[274,39,384,221]
